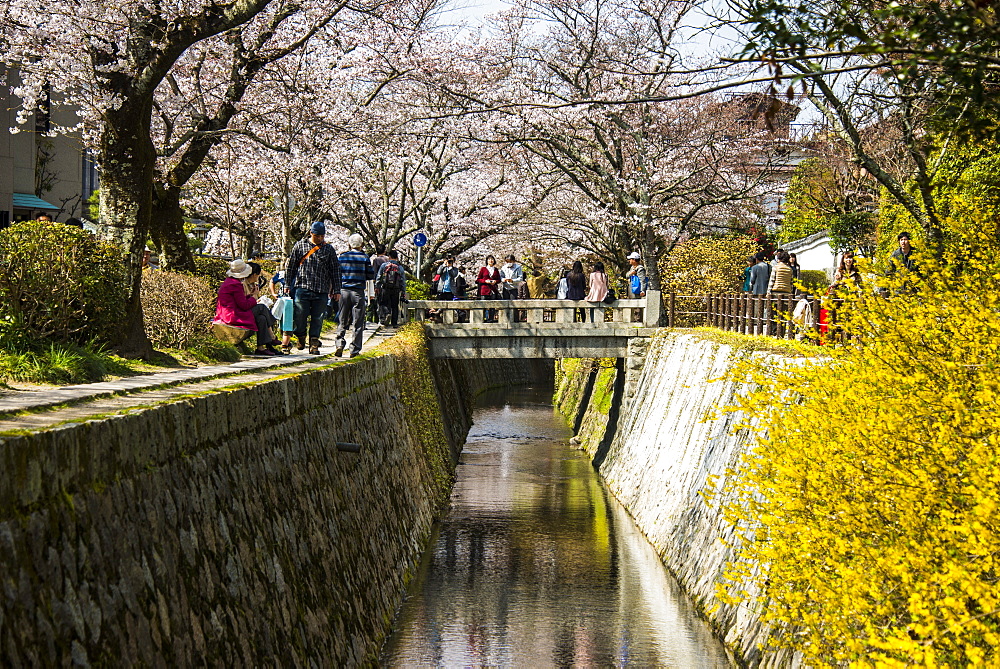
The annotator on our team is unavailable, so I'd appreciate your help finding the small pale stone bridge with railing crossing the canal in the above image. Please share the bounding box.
[408,291,660,359]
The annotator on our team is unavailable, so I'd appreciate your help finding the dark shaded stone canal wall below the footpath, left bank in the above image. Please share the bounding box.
[0,342,470,666]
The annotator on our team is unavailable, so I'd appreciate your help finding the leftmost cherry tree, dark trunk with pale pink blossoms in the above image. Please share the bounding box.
[0,0,296,355]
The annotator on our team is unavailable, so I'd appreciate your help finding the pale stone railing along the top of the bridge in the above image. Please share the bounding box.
[407,293,660,329]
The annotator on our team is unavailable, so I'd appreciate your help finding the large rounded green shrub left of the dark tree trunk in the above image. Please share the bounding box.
[0,221,128,344]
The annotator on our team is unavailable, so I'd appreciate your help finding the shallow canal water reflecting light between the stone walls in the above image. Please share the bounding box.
[381,388,730,668]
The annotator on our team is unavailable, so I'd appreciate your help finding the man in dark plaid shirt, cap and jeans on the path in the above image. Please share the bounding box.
[285,221,341,355]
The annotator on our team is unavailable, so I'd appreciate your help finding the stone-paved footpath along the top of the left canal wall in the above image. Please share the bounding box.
[0,323,394,420]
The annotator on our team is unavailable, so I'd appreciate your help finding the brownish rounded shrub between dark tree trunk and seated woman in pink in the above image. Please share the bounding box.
[142,270,216,348]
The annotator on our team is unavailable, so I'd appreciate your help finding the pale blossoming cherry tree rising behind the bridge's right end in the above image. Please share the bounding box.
[443,0,794,302]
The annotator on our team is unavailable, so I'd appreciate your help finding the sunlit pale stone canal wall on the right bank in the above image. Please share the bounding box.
[556,333,795,666]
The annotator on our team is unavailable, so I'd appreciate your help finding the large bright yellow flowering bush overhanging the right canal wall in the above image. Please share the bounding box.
[715,224,1000,667]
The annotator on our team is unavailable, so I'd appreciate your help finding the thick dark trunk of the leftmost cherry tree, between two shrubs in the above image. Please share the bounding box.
[100,101,156,358]
